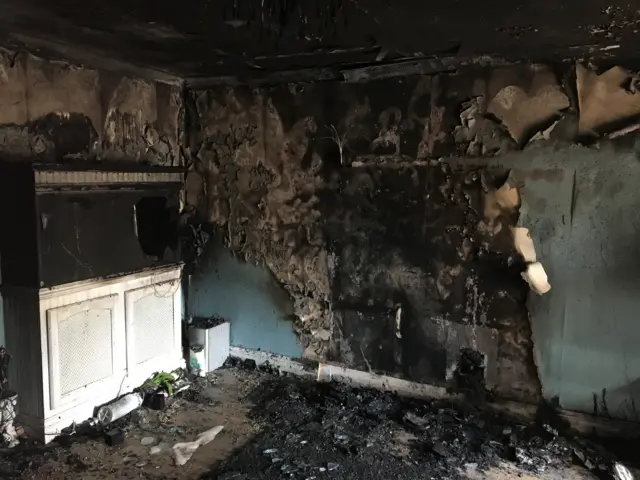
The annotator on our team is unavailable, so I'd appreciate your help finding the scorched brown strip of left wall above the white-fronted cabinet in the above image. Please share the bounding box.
[0,51,182,165]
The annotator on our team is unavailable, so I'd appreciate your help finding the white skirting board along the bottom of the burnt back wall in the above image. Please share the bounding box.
[230,347,638,437]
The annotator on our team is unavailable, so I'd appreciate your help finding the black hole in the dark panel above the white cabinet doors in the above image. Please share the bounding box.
[134,196,178,260]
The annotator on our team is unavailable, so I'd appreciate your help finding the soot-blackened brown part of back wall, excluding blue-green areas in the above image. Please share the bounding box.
[186,67,584,401]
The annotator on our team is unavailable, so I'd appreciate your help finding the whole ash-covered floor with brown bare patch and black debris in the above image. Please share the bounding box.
[0,368,640,480]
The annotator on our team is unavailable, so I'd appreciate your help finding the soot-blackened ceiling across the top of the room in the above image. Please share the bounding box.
[0,0,640,82]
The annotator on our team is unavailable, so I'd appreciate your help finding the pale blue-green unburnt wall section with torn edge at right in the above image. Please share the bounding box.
[450,142,640,421]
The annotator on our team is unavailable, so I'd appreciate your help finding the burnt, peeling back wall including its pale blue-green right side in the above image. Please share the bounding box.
[187,60,640,412]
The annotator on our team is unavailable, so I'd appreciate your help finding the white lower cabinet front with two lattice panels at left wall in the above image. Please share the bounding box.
[31,266,184,441]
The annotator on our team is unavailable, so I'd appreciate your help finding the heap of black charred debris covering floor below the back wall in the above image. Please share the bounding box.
[205,361,633,480]
